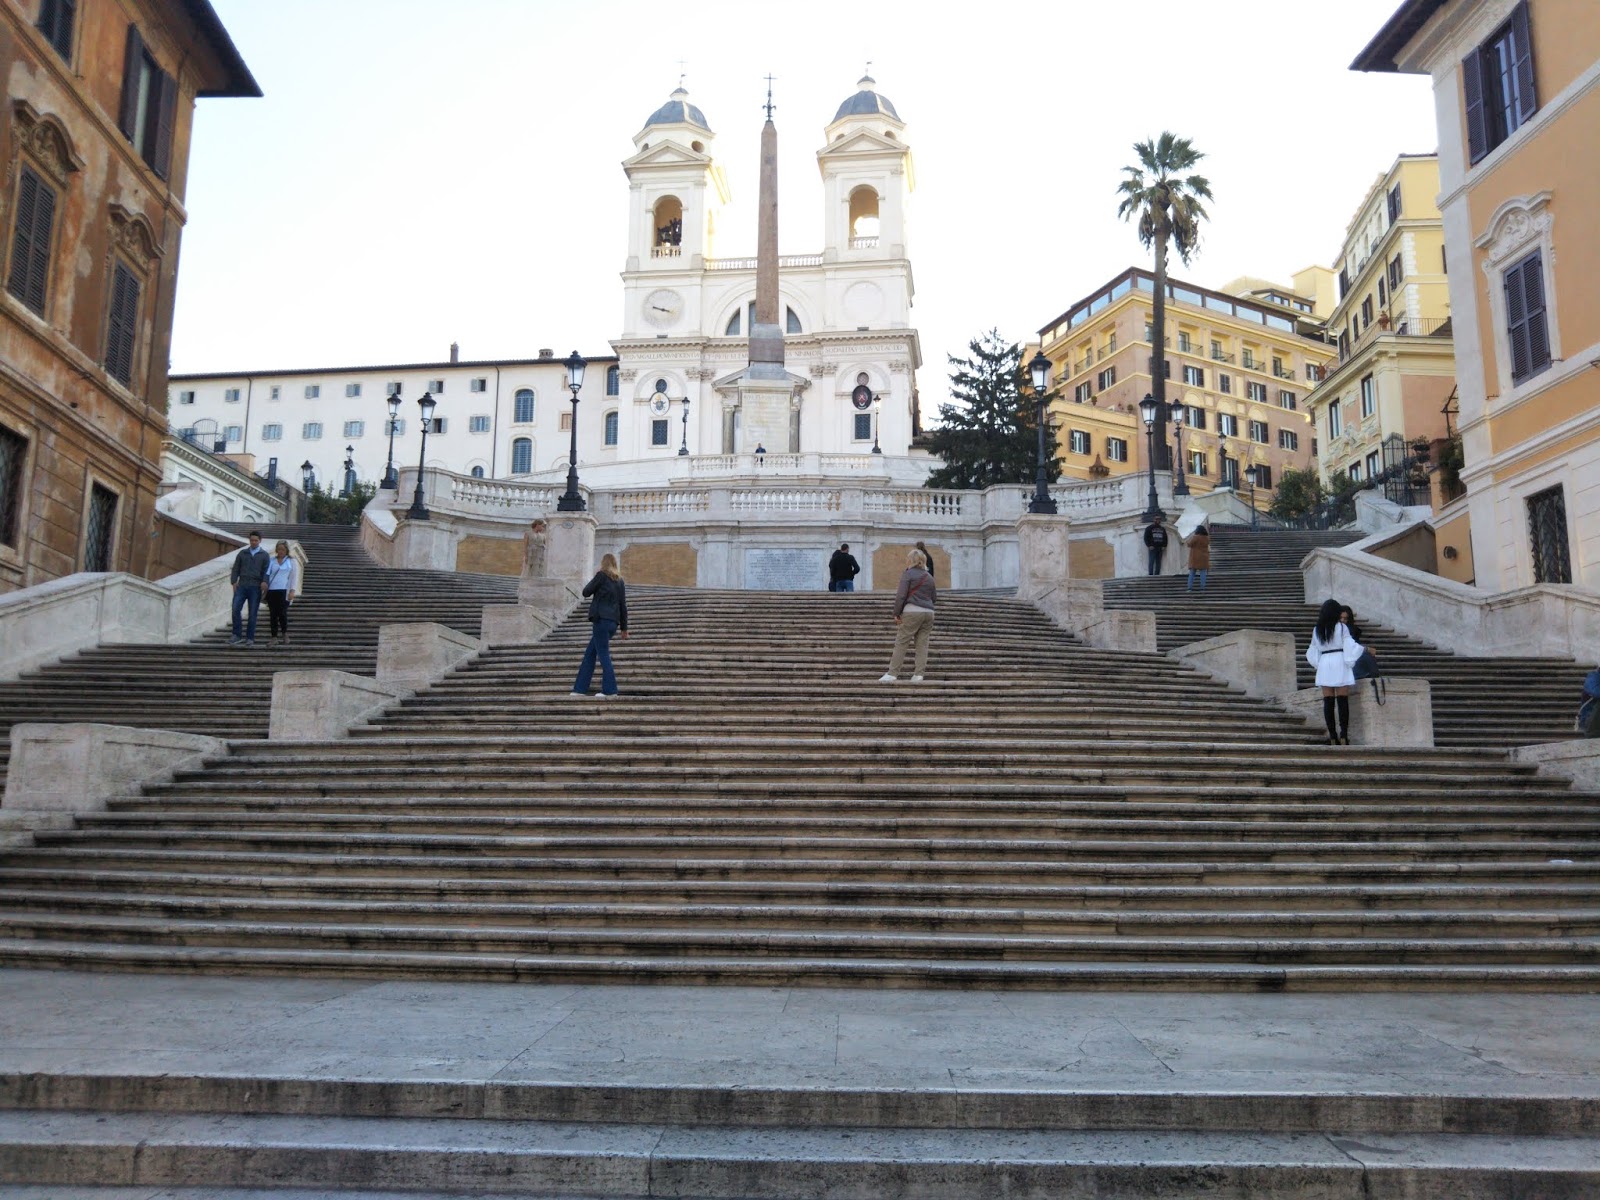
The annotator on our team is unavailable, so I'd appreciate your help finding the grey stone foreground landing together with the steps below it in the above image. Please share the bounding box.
[0,970,1600,1200]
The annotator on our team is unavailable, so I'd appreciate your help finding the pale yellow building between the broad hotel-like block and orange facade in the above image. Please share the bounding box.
[1309,154,1456,492]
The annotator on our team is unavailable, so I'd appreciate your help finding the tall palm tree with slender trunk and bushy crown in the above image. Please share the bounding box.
[1117,131,1211,470]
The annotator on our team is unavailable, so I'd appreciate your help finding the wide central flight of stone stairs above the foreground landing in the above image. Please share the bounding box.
[0,556,1600,989]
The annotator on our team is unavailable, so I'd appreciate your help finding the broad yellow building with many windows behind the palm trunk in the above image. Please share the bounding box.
[1040,267,1334,507]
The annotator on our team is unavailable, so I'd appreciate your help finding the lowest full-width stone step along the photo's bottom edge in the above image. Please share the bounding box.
[0,1112,1600,1200]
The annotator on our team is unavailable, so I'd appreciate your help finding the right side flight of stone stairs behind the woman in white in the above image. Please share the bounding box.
[1104,526,1587,747]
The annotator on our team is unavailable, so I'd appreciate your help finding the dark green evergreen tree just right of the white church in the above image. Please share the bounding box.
[926,330,1061,488]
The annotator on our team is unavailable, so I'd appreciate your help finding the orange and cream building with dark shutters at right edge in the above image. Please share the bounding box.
[1352,0,1600,590]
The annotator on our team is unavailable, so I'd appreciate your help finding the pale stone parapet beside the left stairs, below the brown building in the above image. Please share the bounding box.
[0,550,237,680]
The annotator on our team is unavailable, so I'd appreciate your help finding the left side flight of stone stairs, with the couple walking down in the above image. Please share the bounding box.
[0,525,517,787]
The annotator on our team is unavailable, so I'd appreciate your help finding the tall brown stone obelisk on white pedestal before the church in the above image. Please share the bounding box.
[739,77,798,453]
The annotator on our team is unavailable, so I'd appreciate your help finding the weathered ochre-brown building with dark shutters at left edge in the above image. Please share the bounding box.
[0,0,261,592]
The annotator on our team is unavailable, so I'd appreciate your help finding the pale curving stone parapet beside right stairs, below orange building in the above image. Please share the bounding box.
[1301,544,1600,662]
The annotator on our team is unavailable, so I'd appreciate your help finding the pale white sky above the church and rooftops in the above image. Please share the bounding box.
[173,0,1437,414]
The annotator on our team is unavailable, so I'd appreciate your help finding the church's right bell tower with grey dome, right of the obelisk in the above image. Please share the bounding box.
[816,75,917,262]
